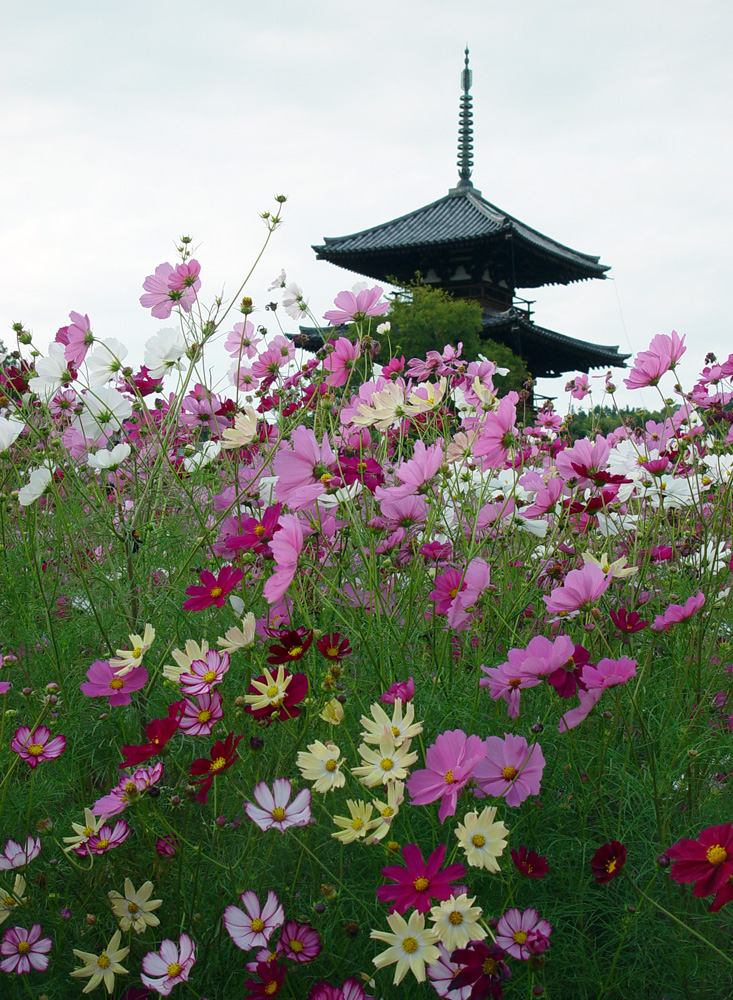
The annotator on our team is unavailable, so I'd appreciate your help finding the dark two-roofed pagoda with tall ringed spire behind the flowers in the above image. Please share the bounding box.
[310,49,629,378]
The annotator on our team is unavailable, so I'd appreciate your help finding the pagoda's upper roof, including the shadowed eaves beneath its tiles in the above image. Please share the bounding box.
[313,183,609,288]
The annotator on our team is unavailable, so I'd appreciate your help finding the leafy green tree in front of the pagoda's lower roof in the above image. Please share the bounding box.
[378,281,529,395]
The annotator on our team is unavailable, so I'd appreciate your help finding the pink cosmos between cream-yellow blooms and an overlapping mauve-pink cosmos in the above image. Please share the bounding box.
[407,729,486,823]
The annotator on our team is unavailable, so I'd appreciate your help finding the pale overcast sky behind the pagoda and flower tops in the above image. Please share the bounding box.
[0,0,733,406]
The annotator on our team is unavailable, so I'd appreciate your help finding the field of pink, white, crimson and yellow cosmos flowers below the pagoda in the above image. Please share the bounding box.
[0,221,733,1000]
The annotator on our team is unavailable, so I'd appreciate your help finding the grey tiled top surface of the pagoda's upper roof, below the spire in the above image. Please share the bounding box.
[313,185,609,288]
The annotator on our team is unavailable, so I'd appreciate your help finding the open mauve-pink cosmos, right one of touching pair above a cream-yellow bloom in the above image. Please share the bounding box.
[473,733,545,806]
